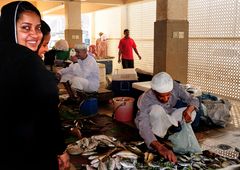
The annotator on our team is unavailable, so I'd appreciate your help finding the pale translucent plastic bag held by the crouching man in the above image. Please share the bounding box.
[168,122,202,154]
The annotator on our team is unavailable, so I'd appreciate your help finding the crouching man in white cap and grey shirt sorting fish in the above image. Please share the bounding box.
[135,72,200,163]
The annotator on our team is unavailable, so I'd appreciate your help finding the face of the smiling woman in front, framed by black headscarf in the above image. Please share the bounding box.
[17,11,42,51]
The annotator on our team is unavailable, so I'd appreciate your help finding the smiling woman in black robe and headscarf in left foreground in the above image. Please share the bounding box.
[0,1,69,170]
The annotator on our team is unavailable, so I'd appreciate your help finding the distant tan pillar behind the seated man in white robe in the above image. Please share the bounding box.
[64,1,82,47]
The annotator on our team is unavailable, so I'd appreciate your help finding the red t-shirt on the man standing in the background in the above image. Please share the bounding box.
[118,37,137,60]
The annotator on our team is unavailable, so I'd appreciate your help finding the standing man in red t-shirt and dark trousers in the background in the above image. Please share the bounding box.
[118,29,142,68]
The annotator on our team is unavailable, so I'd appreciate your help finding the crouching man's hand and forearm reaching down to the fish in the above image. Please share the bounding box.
[150,141,177,163]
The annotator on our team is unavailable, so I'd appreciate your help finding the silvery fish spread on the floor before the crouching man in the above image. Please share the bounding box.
[67,135,240,170]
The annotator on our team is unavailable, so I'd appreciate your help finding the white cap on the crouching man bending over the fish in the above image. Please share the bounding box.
[151,72,173,93]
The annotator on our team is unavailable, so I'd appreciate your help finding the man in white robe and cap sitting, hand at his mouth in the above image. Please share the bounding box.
[57,44,100,97]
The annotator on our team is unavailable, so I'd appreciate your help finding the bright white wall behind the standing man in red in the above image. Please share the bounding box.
[93,1,156,72]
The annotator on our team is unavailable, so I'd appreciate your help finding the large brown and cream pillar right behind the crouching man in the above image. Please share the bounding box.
[153,0,189,83]
